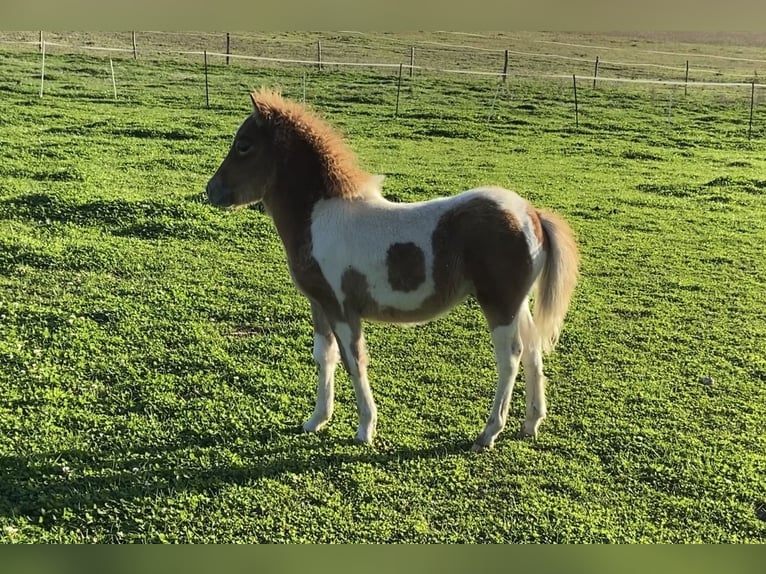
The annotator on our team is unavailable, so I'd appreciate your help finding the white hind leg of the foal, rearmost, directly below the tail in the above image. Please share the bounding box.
[519,302,547,436]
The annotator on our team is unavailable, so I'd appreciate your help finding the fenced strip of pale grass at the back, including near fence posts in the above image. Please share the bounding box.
[0,31,766,135]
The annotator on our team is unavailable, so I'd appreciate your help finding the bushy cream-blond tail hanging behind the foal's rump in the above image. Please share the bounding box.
[534,210,580,352]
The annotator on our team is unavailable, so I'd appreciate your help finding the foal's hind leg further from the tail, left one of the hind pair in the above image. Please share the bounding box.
[472,317,523,451]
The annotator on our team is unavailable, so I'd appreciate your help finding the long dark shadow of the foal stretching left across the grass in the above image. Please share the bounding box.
[0,425,470,526]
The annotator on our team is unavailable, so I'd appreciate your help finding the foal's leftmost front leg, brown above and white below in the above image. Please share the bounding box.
[303,302,340,432]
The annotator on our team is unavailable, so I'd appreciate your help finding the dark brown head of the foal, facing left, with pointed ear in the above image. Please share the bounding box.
[207,93,278,207]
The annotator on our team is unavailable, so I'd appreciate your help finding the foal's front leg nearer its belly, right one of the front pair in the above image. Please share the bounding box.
[334,320,378,443]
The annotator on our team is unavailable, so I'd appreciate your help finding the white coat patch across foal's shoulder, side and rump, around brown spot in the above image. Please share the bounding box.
[311,187,542,320]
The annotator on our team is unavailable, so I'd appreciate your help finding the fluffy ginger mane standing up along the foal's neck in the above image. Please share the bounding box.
[250,88,383,199]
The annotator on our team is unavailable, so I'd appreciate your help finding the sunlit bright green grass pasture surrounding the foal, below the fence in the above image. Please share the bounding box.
[0,36,766,542]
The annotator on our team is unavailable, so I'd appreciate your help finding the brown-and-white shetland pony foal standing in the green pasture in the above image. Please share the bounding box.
[207,90,578,450]
